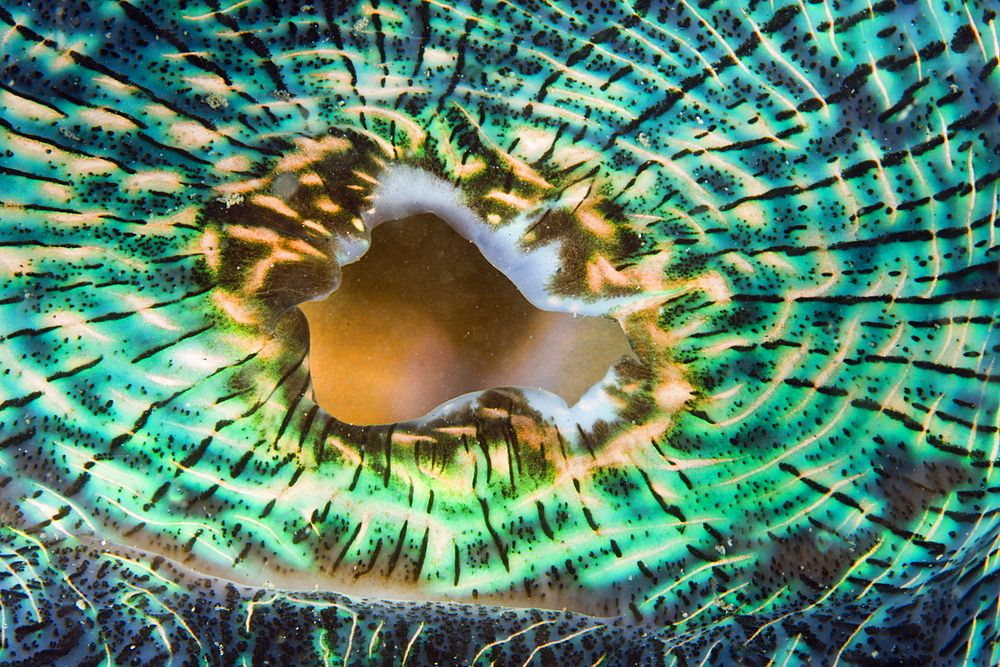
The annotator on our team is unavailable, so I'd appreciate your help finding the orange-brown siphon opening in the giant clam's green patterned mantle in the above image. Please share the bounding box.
[301,214,631,424]
